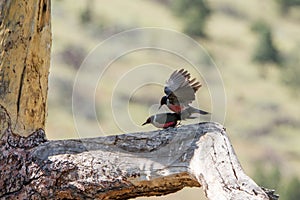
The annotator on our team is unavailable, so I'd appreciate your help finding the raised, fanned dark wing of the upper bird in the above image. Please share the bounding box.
[164,69,202,104]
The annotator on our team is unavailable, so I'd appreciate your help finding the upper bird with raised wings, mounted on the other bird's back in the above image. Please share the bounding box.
[159,69,210,119]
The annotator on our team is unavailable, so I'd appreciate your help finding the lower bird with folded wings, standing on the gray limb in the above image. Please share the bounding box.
[142,113,181,129]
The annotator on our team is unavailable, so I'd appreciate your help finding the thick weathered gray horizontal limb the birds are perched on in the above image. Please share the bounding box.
[0,122,276,200]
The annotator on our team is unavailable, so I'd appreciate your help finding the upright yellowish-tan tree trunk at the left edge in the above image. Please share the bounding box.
[0,0,51,136]
